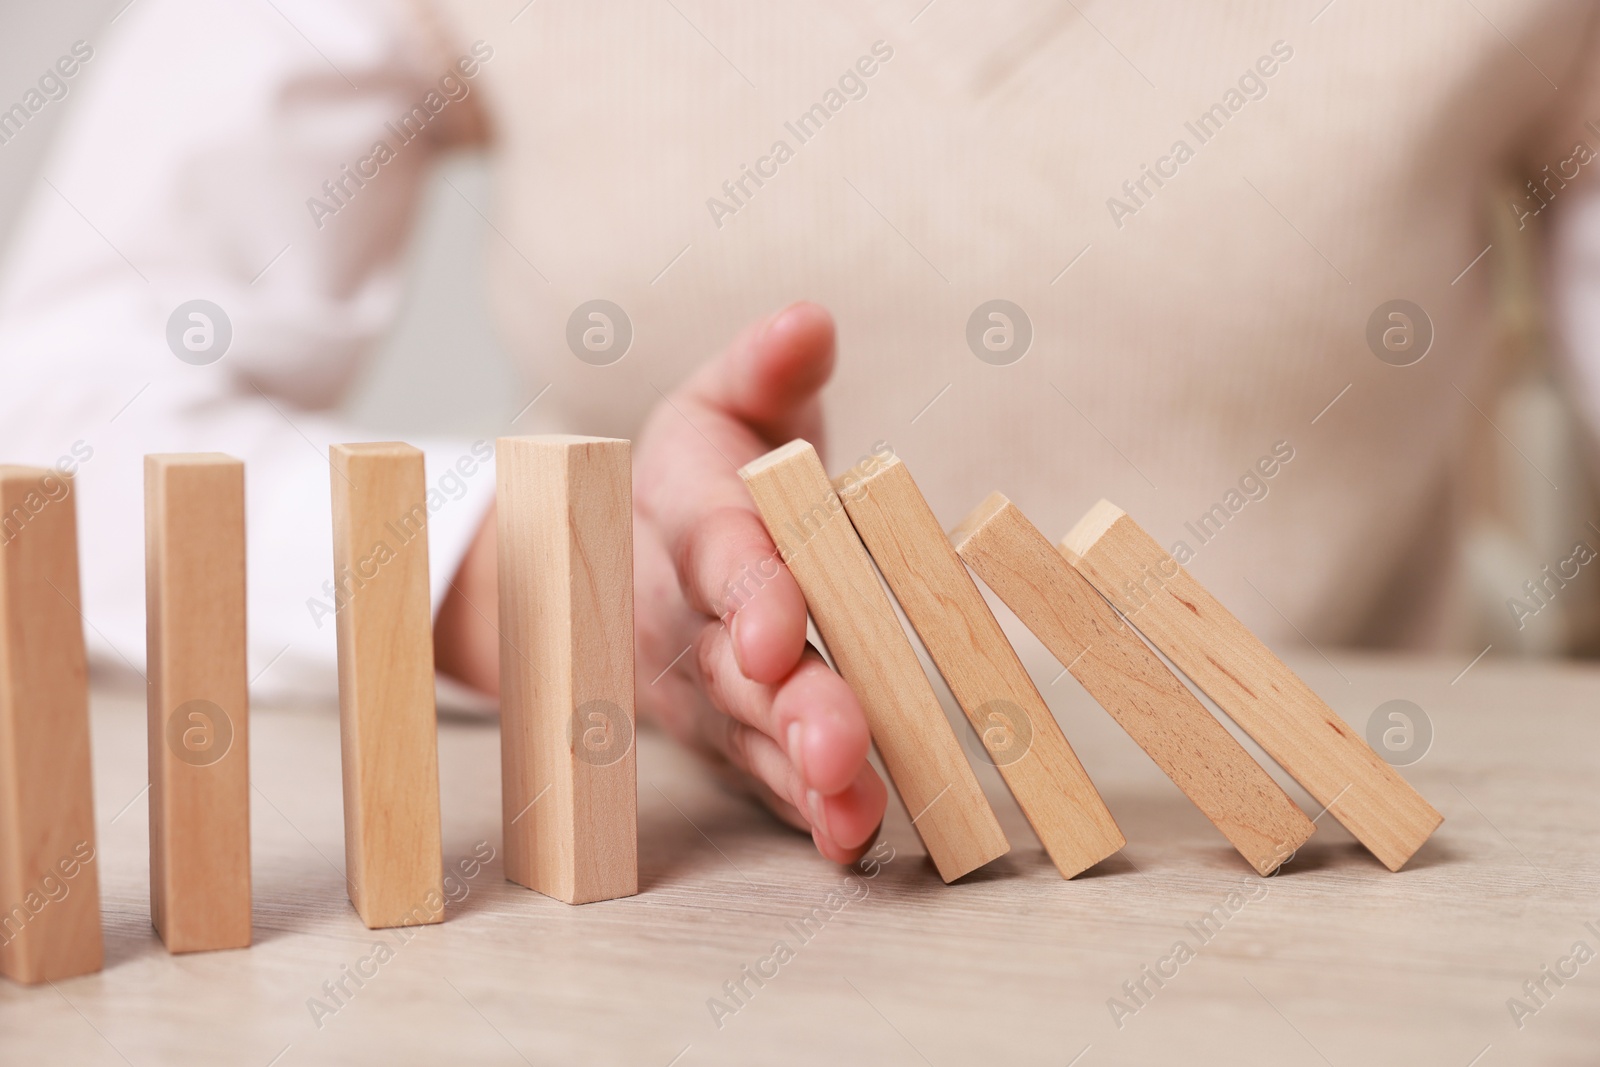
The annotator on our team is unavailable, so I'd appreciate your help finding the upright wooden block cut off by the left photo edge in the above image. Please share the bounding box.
[0,467,102,984]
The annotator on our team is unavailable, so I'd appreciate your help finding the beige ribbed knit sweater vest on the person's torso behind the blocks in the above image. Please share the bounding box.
[432,0,1600,645]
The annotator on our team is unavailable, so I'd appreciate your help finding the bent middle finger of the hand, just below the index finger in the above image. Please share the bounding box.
[696,625,870,808]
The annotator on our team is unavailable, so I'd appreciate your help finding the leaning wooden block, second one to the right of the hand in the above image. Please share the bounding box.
[834,456,1128,878]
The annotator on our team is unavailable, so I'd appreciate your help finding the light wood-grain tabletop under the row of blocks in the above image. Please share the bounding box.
[0,646,1600,1067]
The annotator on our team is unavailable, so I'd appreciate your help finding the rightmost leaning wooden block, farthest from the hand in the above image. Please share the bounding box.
[1061,501,1445,870]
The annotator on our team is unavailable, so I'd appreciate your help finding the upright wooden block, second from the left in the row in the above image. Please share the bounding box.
[144,453,250,952]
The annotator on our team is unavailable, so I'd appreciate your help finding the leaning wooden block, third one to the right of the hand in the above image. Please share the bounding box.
[950,493,1315,875]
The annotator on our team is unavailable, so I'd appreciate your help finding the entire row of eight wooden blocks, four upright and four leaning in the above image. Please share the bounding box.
[0,437,1442,982]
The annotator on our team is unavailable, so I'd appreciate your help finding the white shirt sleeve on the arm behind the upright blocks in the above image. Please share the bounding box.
[0,0,494,693]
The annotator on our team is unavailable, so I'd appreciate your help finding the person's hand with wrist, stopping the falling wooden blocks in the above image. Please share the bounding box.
[435,304,888,864]
